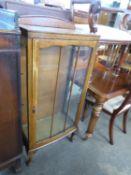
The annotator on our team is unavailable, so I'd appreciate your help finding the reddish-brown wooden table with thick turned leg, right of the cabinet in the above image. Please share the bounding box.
[86,63,131,139]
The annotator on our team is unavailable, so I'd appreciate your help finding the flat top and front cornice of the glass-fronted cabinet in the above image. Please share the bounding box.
[20,25,99,42]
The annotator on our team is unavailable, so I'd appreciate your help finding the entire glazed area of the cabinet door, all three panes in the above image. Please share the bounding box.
[36,46,91,141]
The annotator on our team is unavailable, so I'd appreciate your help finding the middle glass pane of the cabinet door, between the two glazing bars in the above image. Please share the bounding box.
[51,46,74,135]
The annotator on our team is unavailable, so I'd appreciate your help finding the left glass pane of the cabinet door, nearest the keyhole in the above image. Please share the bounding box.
[36,47,60,141]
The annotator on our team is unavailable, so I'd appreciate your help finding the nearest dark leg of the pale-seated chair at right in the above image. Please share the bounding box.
[109,116,115,145]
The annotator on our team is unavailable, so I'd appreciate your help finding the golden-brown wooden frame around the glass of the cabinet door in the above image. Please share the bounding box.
[28,38,98,150]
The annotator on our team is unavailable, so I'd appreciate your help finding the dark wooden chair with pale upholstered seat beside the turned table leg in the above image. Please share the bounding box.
[103,90,131,145]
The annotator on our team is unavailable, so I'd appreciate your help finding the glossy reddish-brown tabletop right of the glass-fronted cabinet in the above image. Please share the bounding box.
[89,69,131,99]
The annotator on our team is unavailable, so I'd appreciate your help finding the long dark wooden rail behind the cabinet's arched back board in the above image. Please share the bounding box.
[0,0,71,20]
